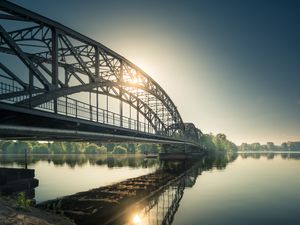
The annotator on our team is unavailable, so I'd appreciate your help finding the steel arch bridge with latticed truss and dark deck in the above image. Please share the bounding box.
[0,0,198,146]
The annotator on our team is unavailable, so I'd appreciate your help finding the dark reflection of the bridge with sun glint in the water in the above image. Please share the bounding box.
[40,162,199,225]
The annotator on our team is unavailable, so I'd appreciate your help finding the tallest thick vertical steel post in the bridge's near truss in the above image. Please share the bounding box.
[51,28,58,113]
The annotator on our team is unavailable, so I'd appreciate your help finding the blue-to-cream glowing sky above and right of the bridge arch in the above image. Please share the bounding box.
[12,0,300,144]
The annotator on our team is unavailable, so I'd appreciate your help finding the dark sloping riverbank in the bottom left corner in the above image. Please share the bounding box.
[0,197,76,225]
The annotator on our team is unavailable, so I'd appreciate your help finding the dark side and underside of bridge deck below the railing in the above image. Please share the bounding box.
[0,103,189,144]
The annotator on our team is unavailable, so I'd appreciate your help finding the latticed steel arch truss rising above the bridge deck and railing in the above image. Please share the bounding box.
[0,0,199,141]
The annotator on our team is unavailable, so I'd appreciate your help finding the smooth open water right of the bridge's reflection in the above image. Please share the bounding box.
[173,154,300,225]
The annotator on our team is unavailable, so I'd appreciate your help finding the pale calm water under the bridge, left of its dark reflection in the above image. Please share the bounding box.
[0,155,156,203]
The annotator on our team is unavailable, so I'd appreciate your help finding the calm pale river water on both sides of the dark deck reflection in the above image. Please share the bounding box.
[0,153,300,225]
